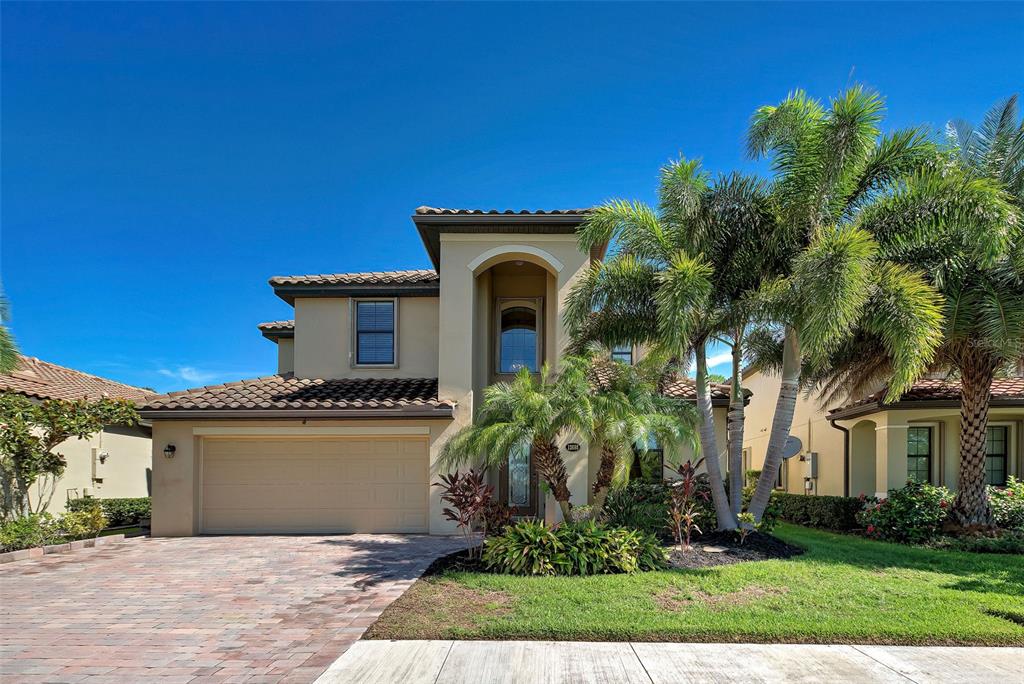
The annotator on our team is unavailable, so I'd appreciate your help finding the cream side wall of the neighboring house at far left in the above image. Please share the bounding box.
[33,426,152,513]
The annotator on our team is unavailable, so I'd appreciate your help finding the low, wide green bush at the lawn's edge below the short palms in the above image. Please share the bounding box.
[483,520,666,575]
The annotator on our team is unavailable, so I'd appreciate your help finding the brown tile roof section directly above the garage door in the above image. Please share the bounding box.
[139,373,455,415]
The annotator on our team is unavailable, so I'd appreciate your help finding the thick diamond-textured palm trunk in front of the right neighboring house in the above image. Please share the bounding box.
[952,350,994,528]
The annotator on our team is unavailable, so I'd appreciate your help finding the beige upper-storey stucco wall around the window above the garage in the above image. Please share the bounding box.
[294,297,439,379]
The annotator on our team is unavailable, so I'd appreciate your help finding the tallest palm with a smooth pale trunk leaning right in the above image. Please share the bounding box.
[749,86,958,520]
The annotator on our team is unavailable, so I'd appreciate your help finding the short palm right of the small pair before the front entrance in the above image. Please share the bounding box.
[589,349,698,517]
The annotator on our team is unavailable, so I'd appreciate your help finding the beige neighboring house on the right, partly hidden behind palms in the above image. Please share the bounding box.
[743,371,1024,497]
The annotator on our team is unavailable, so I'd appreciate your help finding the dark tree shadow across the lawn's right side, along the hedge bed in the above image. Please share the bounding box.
[781,528,1024,597]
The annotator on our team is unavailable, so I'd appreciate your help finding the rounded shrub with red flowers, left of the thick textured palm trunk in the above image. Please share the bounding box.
[857,482,952,544]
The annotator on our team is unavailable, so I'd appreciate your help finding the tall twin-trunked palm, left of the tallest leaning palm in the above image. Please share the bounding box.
[566,159,780,529]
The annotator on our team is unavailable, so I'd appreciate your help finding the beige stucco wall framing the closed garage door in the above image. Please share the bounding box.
[153,419,457,537]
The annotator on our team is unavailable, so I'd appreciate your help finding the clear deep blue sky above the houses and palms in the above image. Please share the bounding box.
[0,2,1024,390]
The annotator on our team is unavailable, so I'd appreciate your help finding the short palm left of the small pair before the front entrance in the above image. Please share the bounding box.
[440,357,594,520]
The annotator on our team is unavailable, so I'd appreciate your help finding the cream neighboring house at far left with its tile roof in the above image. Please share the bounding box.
[0,356,156,513]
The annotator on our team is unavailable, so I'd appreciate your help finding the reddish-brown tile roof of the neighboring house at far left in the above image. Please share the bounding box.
[0,355,156,402]
